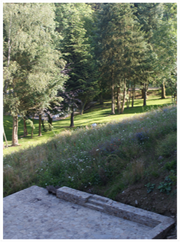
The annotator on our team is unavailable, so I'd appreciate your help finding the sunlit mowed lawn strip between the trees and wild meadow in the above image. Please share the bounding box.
[3,95,172,155]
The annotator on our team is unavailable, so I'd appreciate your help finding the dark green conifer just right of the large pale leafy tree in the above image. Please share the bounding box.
[56,3,97,114]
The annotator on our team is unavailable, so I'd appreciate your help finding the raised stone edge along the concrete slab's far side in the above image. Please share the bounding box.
[56,186,175,239]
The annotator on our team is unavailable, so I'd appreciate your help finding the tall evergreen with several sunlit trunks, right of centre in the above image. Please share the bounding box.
[96,3,146,114]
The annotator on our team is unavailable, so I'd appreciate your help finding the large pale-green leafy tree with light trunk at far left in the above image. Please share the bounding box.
[3,3,67,144]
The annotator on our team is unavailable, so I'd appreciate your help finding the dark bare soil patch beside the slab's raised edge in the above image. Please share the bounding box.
[115,178,177,239]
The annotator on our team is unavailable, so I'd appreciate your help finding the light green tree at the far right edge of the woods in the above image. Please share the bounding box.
[152,3,177,98]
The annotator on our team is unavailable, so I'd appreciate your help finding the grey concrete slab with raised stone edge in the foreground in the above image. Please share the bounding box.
[3,186,174,239]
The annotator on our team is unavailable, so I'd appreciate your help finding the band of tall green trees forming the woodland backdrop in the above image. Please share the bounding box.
[3,3,177,146]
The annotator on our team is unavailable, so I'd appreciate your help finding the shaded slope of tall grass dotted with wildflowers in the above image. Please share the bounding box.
[4,103,177,197]
